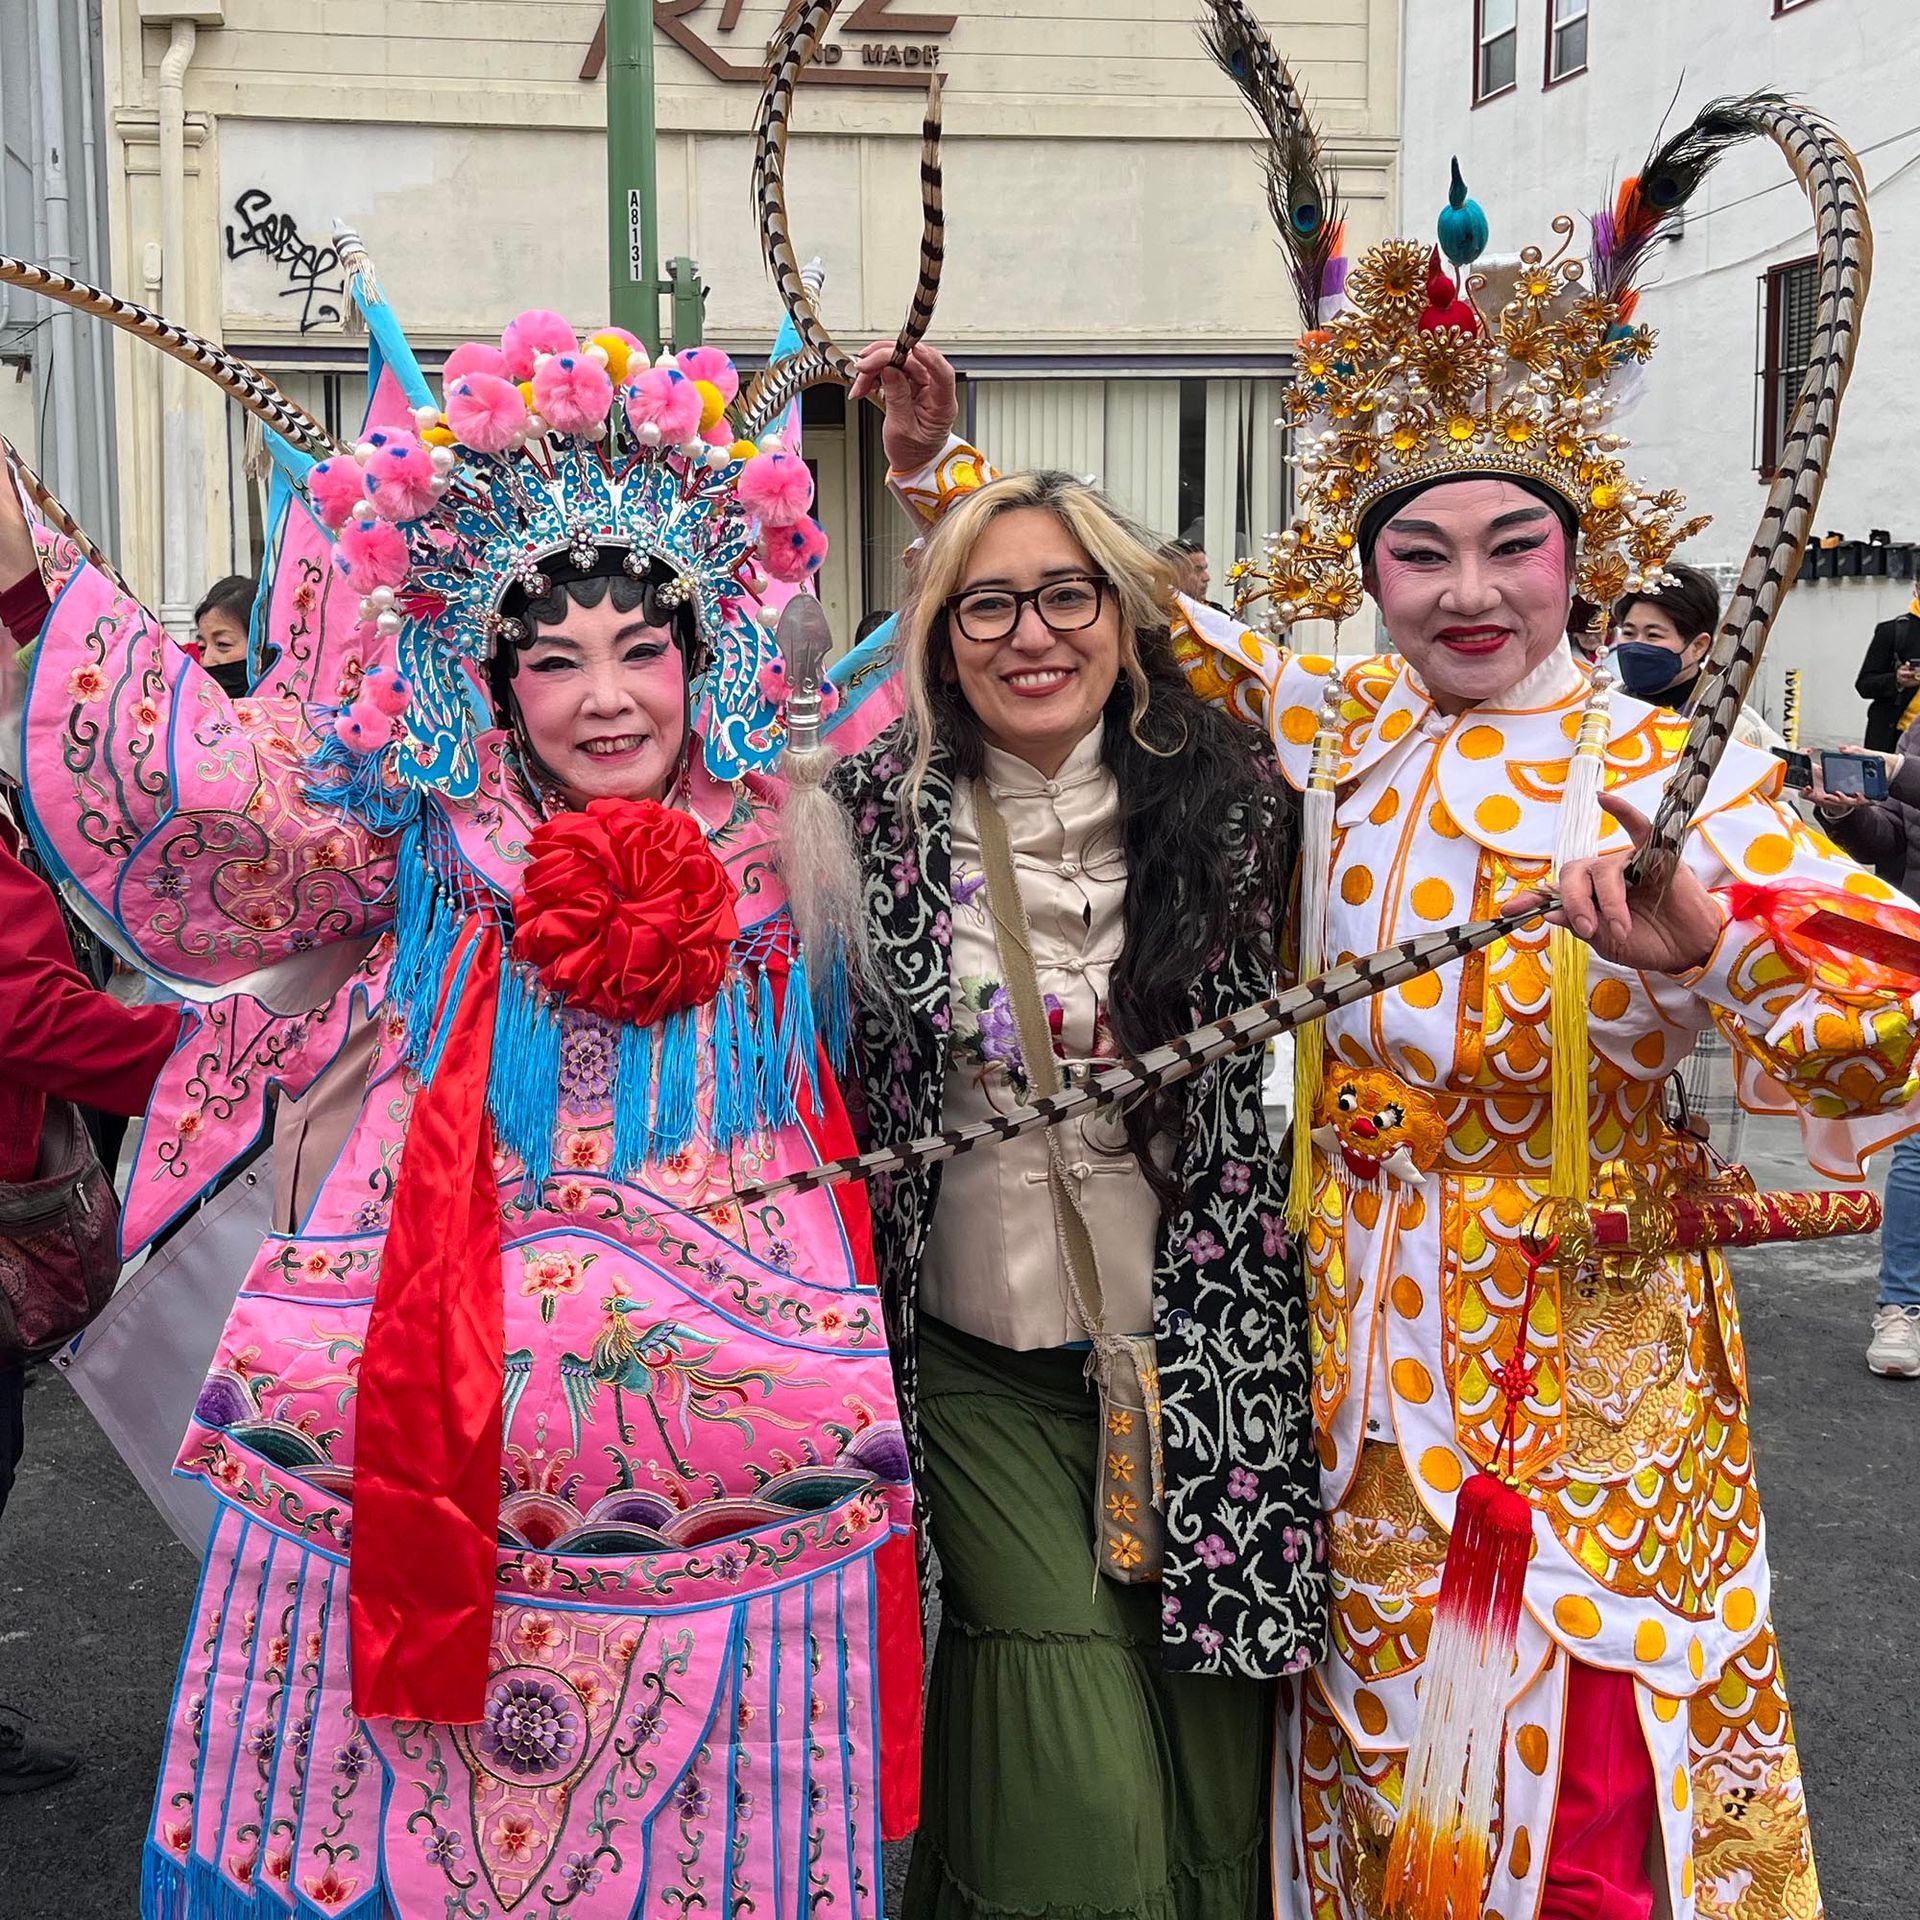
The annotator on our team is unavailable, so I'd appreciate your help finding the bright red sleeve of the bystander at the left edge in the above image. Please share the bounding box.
[0,833,180,1114]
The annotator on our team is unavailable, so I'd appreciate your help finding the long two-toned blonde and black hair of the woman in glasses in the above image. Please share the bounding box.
[900,472,1292,1206]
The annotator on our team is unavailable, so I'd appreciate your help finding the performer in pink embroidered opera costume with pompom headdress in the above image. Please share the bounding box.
[0,303,920,1920]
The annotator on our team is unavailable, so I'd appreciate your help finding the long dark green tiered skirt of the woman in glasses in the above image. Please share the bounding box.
[906,1319,1275,1920]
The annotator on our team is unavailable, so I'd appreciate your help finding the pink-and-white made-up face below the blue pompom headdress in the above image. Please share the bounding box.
[513,593,687,806]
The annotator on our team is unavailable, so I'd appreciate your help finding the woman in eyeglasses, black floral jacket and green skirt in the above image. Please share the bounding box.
[839,472,1325,1920]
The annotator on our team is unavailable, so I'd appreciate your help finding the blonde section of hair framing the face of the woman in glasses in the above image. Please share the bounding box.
[895,472,1173,818]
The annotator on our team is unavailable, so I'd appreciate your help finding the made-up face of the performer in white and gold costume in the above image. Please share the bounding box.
[1367,480,1572,712]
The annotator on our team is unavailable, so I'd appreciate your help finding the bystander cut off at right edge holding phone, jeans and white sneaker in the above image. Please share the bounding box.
[1809,725,1920,1380]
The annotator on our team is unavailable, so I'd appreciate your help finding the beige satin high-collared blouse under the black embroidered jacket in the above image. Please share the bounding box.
[920,728,1160,1350]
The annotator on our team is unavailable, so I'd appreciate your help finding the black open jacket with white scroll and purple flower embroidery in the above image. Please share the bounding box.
[835,728,1327,1676]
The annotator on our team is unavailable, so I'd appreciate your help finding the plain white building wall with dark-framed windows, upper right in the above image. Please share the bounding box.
[1400,0,1920,745]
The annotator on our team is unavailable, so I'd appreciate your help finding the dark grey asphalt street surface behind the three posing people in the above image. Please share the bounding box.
[0,1125,1920,1920]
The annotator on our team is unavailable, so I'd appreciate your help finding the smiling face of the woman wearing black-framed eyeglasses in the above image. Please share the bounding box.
[947,507,1119,778]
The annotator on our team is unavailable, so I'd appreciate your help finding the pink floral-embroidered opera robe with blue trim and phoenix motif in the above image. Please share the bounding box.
[13,540,920,1920]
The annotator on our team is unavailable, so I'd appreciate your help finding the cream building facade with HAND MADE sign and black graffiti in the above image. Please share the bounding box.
[52,0,1400,648]
